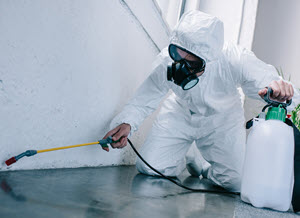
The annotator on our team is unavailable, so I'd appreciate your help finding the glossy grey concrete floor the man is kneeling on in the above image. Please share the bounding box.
[0,166,298,218]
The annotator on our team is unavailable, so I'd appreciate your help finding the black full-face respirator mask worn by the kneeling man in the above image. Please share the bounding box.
[167,44,205,90]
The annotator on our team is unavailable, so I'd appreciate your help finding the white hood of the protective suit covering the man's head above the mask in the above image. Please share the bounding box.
[170,11,224,62]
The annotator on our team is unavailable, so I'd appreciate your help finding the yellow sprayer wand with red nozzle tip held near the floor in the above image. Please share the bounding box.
[5,136,114,166]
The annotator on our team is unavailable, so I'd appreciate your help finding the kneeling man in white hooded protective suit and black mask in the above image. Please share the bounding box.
[104,11,299,192]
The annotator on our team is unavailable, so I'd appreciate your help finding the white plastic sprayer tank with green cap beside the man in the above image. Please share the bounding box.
[241,105,294,211]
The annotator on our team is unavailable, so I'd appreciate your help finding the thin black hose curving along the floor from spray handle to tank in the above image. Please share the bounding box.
[127,139,239,195]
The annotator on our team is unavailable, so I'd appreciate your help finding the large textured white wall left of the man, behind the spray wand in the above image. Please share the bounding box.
[0,0,168,170]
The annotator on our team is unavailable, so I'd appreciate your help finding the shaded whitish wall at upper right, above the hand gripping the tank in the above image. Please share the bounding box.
[253,0,300,87]
